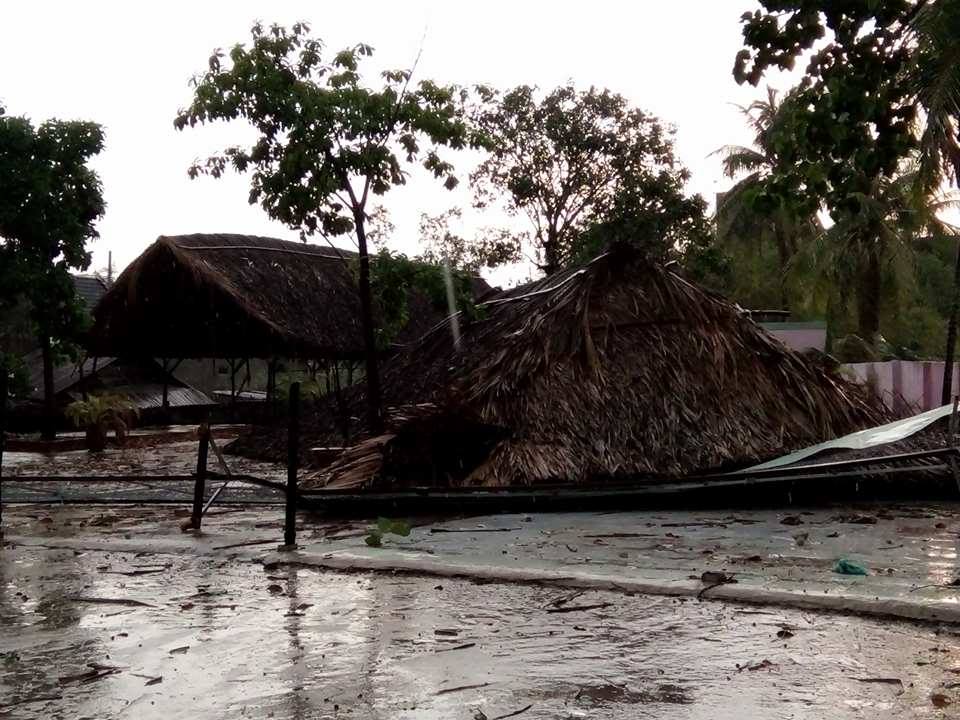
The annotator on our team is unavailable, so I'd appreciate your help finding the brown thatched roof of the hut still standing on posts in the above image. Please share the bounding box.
[89,234,492,359]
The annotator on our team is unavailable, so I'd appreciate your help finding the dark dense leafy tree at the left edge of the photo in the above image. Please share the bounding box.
[0,107,104,439]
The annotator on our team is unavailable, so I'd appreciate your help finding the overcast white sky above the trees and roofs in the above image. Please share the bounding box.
[0,0,786,286]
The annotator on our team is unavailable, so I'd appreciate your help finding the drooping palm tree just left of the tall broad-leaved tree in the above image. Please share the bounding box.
[714,87,822,309]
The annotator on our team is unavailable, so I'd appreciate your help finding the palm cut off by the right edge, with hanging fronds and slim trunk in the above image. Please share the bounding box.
[908,0,960,405]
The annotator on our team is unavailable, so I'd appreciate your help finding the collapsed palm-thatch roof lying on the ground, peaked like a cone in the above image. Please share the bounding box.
[290,246,888,487]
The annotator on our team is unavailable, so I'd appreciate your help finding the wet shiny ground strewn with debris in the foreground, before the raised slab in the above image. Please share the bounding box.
[0,506,960,720]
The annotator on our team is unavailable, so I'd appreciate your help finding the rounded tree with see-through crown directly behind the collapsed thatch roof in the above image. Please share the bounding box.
[471,85,688,274]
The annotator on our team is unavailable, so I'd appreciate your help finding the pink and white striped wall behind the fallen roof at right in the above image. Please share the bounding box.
[844,360,960,415]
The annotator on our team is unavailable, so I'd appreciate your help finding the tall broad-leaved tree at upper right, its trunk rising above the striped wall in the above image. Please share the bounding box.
[734,0,923,344]
